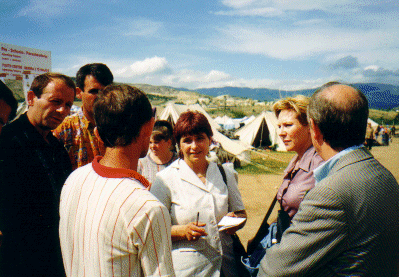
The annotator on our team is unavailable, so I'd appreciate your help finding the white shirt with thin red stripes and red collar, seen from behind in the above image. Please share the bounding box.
[60,157,174,276]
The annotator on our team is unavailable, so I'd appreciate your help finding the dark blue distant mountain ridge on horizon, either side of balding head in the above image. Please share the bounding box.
[196,83,399,110]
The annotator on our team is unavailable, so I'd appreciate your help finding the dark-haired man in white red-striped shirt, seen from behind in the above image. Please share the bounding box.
[59,85,175,276]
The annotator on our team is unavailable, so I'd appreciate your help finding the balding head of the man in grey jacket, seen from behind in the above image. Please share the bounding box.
[308,82,369,150]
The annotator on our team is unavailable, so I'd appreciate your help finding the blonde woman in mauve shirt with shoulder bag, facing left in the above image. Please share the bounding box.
[243,95,323,276]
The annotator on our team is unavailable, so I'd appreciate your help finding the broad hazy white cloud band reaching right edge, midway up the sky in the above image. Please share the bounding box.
[216,25,399,60]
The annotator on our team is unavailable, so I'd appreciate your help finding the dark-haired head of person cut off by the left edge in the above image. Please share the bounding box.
[0,80,18,134]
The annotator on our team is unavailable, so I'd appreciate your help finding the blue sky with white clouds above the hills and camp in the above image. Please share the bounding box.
[0,0,399,90]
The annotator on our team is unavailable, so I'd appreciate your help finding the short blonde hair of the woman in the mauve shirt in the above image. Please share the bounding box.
[273,95,309,126]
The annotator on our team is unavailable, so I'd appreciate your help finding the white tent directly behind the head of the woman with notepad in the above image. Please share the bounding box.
[159,103,250,162]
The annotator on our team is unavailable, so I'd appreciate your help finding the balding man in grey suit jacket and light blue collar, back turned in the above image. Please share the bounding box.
[258,82,399,277]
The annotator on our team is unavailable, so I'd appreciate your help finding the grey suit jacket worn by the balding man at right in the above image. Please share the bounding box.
[258,148,399,277]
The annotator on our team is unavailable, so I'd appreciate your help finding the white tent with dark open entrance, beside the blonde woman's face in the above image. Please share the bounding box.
[235,112,287,151]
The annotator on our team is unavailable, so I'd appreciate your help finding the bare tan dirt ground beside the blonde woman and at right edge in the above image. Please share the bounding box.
[238,138,399,247]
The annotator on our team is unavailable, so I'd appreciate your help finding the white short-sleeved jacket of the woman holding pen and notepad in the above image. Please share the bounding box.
[151,159,244,276]
